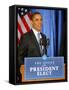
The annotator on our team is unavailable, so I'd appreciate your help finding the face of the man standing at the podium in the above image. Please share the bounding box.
[31,14,42,32]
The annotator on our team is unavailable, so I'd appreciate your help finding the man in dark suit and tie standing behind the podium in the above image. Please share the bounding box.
[18,12,47,81]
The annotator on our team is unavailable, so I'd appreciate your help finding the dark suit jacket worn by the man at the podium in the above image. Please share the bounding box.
[18,30,46,66]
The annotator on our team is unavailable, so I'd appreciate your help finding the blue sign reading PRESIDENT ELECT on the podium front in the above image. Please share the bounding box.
[24,57,64,80]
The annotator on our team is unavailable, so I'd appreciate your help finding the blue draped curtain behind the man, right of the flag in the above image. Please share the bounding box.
[32,9,63,56]
